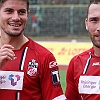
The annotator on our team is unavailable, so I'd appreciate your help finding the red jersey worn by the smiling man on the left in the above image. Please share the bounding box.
[0,39,65,100]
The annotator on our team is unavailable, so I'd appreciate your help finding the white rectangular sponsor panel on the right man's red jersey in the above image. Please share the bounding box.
[78,76,100,94]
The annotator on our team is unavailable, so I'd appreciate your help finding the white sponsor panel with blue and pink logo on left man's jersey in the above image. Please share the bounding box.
[0,71,24,90]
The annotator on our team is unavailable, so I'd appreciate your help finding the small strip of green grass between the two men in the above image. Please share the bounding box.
[59,70,66,93]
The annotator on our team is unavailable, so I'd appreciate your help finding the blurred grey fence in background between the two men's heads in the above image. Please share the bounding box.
[25,0,89,37]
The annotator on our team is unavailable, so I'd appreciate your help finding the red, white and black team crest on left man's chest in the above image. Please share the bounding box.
[27,59,38,76]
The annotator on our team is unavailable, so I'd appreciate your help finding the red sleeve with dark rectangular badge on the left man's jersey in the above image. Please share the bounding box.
[40,54,66,100]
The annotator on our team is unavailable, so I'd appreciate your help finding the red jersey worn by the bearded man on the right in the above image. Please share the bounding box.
[65,48,100,100]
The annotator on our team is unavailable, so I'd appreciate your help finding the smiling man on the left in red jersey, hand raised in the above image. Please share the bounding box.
[0,0,66,100]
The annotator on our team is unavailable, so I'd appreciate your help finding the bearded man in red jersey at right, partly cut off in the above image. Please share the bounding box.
[65,0,100,100]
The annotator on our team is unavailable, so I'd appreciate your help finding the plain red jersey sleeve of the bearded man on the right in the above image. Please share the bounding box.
[65,58,81,100]
